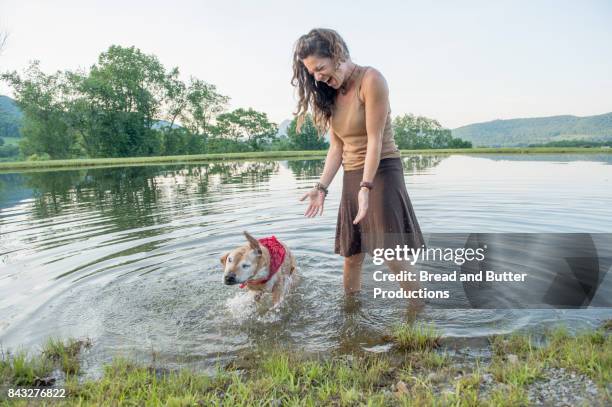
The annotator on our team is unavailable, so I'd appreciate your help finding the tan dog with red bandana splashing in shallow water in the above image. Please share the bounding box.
[221,231,296,307]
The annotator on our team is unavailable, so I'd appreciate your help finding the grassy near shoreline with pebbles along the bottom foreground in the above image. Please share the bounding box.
[0,322,612,406]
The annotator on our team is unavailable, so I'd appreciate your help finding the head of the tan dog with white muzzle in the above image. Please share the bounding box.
[221,232,262,285]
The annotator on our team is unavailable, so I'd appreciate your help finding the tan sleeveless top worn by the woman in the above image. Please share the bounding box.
[331,66,400,171]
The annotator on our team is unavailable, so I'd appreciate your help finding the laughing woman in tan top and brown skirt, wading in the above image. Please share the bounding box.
[291,29,424,294]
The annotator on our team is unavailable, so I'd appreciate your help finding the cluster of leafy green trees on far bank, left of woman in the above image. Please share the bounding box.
[0,45,314,158]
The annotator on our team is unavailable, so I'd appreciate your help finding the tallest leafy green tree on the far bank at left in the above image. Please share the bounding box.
[74,45,172,157]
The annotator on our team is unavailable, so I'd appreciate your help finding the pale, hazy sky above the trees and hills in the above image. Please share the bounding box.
[0,0,612,128]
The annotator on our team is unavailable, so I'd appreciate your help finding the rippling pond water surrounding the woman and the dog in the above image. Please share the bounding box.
[0,154,612,369]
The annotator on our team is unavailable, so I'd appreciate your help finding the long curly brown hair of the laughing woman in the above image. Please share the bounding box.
[291,28,350,135]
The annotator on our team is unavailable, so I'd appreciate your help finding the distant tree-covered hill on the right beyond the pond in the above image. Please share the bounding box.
[452,113,612,147]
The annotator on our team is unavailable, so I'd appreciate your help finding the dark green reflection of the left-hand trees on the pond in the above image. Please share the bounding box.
[0,161,278,223]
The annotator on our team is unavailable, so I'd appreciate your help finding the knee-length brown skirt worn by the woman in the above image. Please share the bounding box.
[334,158,425,257]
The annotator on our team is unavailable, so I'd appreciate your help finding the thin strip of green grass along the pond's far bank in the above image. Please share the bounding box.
[0,147,612,172]
